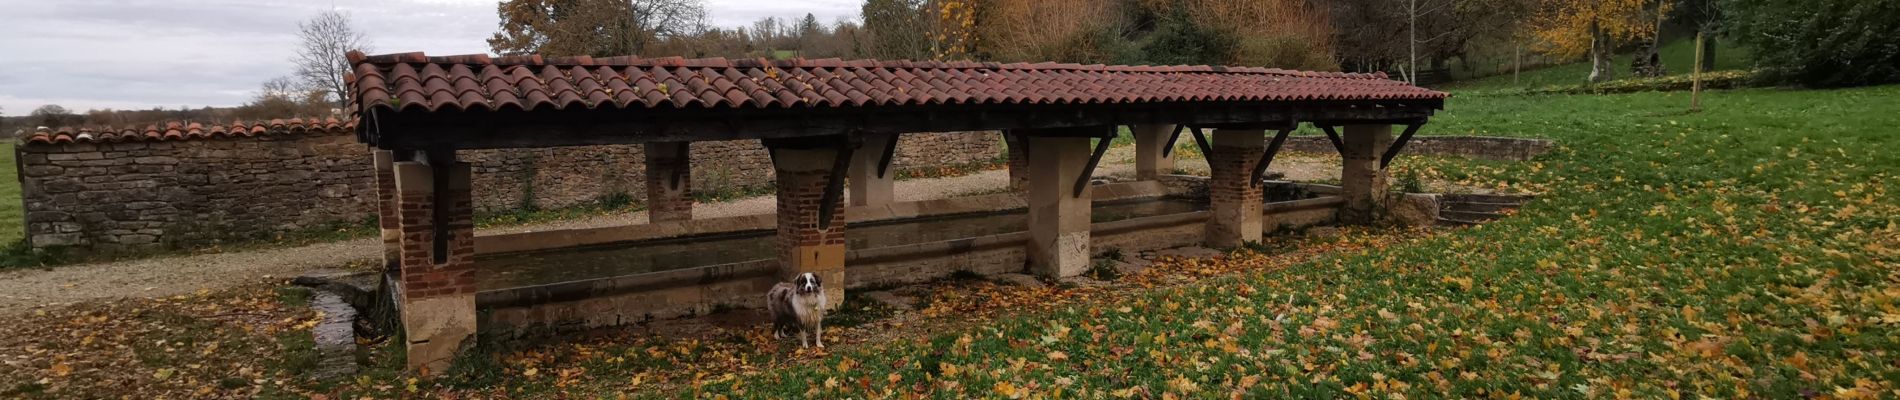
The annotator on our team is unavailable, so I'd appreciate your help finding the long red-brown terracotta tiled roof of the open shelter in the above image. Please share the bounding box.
[350,51,1446,112]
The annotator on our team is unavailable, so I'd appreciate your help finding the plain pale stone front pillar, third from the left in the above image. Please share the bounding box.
[1022,136,1091,279]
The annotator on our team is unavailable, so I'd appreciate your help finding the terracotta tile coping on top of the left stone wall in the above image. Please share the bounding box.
[23,118,355,144]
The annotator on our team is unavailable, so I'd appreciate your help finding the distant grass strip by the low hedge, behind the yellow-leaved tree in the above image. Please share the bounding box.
[1435,38,1754,91]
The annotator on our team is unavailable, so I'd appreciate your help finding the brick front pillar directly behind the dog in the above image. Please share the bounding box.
[771,148,846,305]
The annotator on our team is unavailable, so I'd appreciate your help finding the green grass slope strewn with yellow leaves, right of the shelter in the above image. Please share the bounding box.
[705,87,1900,398]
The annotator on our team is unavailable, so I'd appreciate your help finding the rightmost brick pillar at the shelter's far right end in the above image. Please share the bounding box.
[1340,125,1393,224]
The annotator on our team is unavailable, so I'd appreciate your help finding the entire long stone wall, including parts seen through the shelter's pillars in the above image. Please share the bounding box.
[15,133,1001,252]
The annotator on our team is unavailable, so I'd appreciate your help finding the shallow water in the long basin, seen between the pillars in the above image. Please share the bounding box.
[475,199,1207,290]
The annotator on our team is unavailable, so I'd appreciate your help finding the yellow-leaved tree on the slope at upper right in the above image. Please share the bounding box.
[1528,0,1668,83]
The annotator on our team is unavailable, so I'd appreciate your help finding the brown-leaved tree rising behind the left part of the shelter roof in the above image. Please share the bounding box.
[488,0,705,55]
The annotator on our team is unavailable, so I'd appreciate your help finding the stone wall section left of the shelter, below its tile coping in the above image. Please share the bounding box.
[17,135,376,252]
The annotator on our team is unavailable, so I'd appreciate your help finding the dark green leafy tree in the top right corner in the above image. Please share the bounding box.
[1723,0,1900,87]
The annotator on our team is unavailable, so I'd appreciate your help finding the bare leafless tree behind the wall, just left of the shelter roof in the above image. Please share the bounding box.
[291,11,371,108]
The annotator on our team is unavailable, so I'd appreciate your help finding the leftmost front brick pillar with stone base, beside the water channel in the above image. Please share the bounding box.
[395,157,475,375]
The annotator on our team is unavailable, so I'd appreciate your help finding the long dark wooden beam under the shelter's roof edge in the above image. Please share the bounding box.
[359,99,1444,150]
